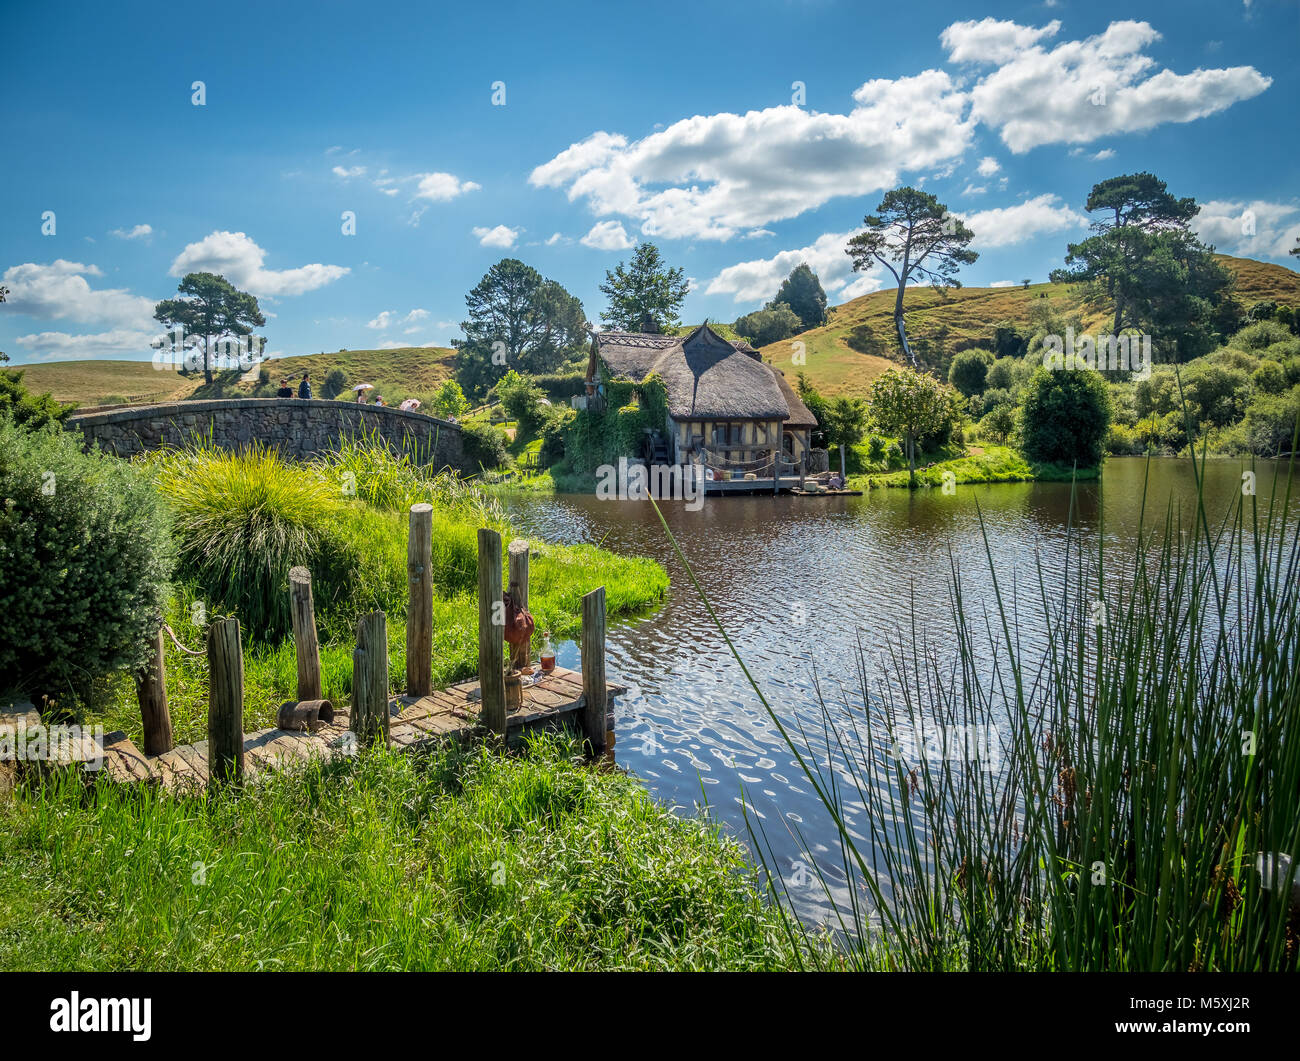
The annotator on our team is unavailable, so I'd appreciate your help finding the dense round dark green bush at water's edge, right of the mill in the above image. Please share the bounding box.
[1021,363,1110,468]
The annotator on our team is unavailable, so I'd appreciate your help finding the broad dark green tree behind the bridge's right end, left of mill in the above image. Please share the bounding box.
[452,257,586,399]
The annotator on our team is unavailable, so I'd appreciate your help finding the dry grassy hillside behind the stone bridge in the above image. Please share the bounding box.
[18,346,455,408]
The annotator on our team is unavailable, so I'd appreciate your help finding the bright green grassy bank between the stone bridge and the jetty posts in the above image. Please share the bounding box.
[90,443,668,742]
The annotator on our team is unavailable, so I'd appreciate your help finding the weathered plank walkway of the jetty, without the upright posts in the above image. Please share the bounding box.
[85,667,627,791]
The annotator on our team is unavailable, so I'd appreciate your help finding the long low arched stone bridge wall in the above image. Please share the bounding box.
[66,398,464,471]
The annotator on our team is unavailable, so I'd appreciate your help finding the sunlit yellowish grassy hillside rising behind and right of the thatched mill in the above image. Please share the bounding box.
[762,255,1300,398]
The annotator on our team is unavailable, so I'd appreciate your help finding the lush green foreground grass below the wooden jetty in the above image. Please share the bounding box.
[0,739,790,970]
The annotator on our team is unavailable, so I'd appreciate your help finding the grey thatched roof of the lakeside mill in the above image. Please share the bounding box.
[597,324,811,426]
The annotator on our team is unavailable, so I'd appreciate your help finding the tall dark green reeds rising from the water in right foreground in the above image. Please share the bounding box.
[655,447,1300,971]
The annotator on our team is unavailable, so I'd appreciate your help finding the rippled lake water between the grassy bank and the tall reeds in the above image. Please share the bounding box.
[508,458,1284,921]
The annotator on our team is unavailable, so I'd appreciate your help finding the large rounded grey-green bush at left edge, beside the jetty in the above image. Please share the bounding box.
[0,416,173,701]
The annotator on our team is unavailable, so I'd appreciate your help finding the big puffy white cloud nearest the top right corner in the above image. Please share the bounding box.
[940,18,1271,153]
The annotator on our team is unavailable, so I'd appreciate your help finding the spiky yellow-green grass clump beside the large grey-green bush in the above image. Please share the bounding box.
[150,442,348,640]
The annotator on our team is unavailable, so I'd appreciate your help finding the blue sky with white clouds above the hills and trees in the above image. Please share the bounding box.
[0,0,1300,364]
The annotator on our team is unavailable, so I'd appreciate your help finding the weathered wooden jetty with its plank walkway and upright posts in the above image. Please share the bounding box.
[0,514,627,791]
